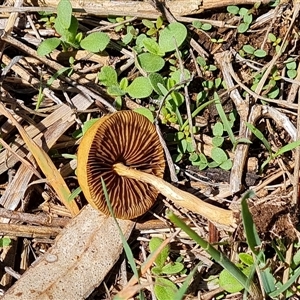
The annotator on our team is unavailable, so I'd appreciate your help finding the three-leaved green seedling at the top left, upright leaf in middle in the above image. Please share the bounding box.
[37,0,110,56]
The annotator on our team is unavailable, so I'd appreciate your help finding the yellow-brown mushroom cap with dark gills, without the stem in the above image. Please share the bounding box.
[77,111,165,219]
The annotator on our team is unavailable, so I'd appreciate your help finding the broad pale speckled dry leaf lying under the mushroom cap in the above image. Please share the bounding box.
[1,205,134,300]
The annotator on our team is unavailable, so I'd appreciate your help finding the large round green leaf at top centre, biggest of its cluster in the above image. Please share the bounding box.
[158,22,187,52]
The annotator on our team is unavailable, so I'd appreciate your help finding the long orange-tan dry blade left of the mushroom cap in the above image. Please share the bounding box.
[0,103,79,216]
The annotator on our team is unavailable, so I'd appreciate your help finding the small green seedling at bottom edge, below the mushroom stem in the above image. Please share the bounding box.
[149,237,184,300]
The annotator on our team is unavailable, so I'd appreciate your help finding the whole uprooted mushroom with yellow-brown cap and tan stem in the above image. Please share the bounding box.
[77,111,235,226]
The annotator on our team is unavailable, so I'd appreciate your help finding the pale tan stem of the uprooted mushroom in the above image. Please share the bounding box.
[113,163,236,227]
